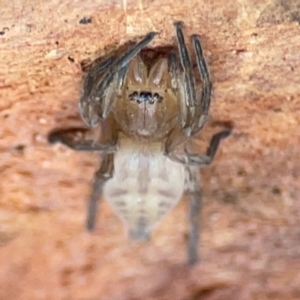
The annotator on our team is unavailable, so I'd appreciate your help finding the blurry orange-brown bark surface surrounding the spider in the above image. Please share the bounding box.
[0,0,300,300]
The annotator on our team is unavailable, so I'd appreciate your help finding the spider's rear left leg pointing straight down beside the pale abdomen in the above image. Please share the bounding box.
[86,153,114,231]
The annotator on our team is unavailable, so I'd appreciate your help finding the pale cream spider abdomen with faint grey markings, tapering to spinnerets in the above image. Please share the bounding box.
[104,139,184,240]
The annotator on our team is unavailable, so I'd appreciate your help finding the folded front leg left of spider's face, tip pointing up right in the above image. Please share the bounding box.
[79,32,156,127]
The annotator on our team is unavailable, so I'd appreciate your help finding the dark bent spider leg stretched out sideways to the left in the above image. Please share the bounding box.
[48,116,118,153]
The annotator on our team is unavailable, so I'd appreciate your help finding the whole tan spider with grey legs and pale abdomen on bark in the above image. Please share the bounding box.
[49,22,231,265]
